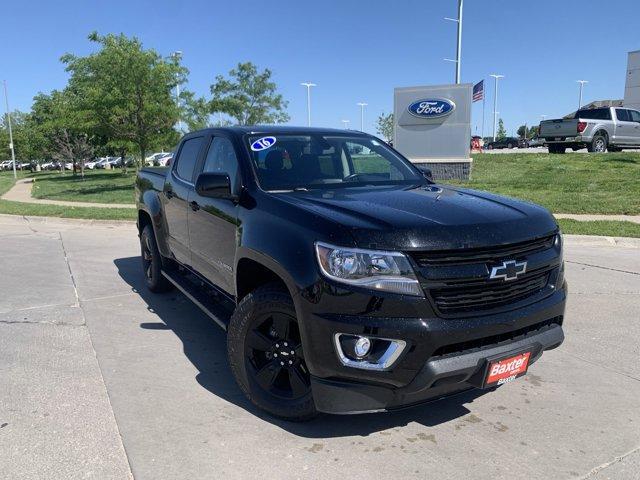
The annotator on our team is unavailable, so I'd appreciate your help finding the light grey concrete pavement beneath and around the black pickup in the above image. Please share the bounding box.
[0,216,640,480]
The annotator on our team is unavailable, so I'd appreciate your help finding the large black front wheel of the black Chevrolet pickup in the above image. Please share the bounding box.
[227,283,318,422]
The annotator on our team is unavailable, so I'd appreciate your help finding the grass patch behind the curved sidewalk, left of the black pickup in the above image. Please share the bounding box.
[32,170,136,203]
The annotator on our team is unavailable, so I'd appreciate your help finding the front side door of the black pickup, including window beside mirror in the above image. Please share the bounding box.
[189,136,241,295]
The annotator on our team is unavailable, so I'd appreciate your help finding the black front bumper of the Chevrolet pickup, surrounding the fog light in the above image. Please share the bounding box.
[297,284,566,414]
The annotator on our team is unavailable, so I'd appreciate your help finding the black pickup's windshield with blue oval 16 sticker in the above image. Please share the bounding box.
[248,134,425,190]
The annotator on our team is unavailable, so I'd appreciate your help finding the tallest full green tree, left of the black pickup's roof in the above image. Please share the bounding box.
[61,32,188,167]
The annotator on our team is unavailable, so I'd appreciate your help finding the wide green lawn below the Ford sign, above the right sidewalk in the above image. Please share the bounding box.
[456,152,640,215]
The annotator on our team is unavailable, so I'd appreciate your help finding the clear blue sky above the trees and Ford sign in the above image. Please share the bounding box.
[0,0,640,134]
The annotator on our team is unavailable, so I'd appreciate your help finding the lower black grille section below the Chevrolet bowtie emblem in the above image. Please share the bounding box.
[429,270,550,315]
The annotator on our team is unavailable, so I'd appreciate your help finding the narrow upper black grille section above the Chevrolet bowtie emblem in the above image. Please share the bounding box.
[409,234,556,267]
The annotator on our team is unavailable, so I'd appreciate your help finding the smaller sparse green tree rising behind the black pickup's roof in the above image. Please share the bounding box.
[209,62,289,125]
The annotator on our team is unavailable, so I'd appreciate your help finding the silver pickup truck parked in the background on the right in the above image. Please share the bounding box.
[539,107,640,153]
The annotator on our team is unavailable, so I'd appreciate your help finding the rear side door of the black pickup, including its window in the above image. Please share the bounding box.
[162,136,204,265]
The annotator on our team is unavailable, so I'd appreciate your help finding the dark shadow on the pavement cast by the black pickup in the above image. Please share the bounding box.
[114,257,486,438]
